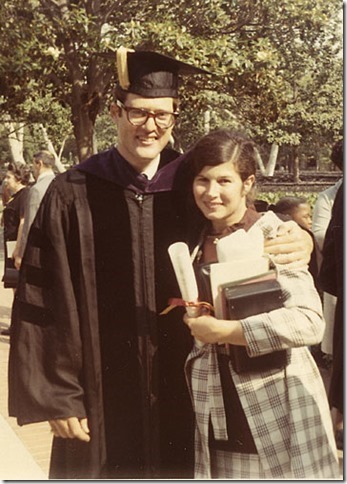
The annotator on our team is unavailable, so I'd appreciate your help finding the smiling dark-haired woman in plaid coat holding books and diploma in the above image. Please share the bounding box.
[184,130,339,480]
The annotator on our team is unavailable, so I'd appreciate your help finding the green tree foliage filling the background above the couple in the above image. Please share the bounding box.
[0,0,343,163]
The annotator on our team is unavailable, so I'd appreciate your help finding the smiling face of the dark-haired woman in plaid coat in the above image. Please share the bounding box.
[193,161,255,232]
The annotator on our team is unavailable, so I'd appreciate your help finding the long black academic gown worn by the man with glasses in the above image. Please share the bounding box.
[9,148,200,479]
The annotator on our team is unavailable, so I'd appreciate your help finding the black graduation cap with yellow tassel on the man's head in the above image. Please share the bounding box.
[117,47,210,98]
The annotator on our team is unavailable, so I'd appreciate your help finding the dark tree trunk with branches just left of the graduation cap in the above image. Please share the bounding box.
[38,0,114,162]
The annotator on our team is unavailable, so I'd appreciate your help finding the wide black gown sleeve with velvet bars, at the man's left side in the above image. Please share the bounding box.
[9,177,86,425]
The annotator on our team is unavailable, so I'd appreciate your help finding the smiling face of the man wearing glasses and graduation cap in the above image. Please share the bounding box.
[111,93,174,171]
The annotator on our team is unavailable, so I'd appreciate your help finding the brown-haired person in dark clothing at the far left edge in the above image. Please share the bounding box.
[1,162,30,336]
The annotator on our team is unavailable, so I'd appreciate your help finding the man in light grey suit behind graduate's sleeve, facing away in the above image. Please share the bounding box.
[12,150,55,270]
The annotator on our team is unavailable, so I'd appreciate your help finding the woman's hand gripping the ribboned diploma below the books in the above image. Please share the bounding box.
[183,314,247,346]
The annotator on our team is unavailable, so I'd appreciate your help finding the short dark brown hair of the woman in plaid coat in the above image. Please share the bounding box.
[188,129,257,181]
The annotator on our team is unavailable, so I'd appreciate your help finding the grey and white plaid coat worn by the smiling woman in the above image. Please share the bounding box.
[185,212,339,479]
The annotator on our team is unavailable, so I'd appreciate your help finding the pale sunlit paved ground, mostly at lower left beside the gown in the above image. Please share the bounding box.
[0,228,343,481]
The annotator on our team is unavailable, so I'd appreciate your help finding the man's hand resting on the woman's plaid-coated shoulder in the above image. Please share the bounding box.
[265,220,314,269]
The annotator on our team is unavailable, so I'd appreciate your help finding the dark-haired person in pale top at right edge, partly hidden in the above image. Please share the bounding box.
[312,139,343,357]
